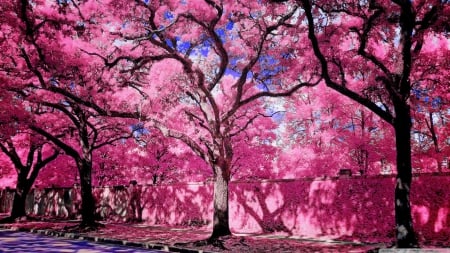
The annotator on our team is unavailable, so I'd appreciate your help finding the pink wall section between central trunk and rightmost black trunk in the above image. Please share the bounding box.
[231,178,394,241]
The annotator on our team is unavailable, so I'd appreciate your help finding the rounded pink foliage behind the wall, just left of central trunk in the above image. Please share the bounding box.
[93,132,210,185]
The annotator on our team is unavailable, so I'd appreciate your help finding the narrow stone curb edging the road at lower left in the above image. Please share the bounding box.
[0,225,214,253]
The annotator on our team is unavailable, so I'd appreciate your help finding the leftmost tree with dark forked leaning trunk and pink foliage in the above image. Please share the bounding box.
[0,86,59,222]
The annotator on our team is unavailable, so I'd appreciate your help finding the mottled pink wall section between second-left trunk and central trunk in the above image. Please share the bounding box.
[94,183,213,226]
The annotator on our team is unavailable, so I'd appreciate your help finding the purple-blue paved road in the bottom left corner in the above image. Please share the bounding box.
[0,229,162,253]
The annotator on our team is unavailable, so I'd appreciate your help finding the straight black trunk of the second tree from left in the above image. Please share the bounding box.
[78,161,96,227]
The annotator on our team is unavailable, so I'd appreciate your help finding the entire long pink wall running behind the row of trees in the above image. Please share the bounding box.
[3,174,450,242]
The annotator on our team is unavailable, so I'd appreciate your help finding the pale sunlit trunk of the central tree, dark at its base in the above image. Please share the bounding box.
[210,166,231,240]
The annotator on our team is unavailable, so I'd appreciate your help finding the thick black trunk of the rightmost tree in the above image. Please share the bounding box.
[394,103,417,248]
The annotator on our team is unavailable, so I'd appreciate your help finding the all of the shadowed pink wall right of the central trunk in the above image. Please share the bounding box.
[230,175,450,244]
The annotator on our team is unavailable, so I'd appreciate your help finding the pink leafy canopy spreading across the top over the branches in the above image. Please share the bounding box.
[0,0,450,188]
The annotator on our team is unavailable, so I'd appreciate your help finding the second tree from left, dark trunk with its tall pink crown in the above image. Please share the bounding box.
[0,1,142,227]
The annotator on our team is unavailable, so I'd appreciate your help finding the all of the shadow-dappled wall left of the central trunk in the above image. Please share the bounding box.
[5,183,213,226]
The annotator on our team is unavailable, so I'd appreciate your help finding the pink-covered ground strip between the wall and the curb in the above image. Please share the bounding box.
[3,215,386,252]
